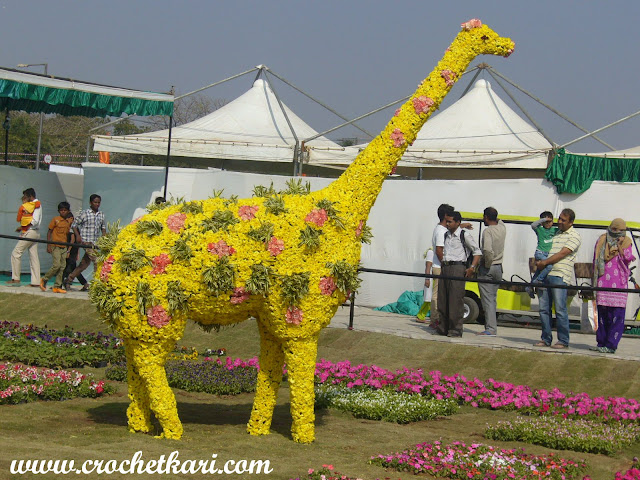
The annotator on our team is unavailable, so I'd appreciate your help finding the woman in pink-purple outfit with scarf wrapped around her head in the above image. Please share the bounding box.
[592,218,635,353]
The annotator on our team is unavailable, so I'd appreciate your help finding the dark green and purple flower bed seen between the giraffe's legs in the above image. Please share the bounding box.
[105,357,258,395]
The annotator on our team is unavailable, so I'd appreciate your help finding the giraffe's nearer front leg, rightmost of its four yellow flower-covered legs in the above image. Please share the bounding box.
[284,336,318,443]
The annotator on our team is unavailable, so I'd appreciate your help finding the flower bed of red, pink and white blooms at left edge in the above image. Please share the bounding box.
[0,363,115,404]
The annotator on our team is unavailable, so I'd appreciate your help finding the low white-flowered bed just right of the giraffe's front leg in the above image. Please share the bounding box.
[316,385,458,423]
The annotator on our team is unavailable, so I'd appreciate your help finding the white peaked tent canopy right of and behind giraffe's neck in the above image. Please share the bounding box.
[312,80,552,169]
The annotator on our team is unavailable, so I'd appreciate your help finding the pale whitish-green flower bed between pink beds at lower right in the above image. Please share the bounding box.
[485,417,640,455]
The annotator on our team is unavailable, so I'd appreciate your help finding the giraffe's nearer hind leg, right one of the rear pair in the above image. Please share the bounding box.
[135,340,182,440]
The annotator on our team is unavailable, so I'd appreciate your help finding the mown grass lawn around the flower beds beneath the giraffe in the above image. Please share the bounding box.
[0,294,640,480]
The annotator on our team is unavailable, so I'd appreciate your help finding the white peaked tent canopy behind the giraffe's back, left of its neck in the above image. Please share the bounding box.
[93,79,344,162]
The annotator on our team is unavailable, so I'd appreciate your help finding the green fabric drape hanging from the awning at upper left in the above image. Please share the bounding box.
[0,79,173,117]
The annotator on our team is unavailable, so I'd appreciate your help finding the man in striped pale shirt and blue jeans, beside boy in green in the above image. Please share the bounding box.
[535,208,581,350]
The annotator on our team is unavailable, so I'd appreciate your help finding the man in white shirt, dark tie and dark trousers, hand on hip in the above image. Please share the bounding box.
[437,212,482,337]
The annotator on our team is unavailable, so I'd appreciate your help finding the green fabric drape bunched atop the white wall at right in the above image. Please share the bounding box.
[545,148,640,193]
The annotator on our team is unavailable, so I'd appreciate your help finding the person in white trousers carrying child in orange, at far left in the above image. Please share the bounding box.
[7,188,42,288]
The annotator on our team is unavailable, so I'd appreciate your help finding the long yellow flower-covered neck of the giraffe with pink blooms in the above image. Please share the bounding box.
[327,26,513,219]
